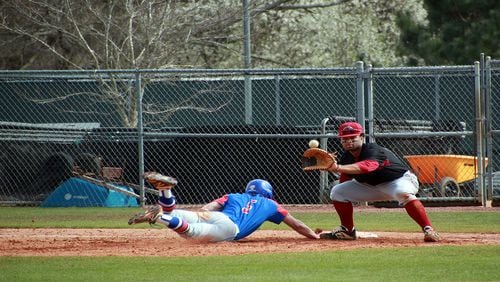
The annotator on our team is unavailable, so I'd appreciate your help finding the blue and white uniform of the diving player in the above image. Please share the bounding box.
[158,180,288,242]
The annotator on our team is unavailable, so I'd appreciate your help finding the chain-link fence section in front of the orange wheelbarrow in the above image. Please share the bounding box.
[372,67,478,198]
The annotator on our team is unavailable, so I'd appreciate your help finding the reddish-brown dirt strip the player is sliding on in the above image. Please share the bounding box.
[0,208,500,256]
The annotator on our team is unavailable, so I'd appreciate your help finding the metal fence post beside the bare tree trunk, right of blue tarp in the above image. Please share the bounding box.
[135,70,146,206]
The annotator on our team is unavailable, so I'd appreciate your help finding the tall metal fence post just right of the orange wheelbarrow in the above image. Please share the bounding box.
[474,61,491,207]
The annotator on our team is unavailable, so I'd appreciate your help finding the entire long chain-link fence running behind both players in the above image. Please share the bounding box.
[0,63,498,205]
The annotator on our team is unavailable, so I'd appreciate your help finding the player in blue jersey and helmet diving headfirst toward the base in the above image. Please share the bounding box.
[129,172,319,242]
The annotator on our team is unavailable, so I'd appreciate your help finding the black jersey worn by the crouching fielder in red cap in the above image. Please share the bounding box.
[339,143,409,185]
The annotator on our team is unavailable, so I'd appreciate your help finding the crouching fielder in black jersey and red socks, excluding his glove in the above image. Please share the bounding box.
[320,122,441,242]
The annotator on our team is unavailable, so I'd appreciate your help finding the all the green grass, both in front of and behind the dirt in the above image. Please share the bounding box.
[0,207,500,281]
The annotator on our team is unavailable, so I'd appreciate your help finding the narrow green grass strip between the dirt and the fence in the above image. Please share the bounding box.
[0,207,500,233]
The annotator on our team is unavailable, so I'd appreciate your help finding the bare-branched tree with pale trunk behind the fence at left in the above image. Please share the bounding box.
[0,0,248,127]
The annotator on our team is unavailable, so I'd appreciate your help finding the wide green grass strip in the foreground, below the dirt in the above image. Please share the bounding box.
[0,246,500,281]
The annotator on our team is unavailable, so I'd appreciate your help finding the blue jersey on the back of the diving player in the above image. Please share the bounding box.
[215,194,288,240]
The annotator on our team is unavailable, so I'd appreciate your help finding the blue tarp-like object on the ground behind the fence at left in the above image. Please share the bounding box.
[41,177,139,207]
